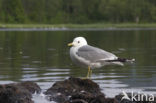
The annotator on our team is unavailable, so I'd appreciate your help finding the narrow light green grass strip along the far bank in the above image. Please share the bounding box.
[0,23,156,28]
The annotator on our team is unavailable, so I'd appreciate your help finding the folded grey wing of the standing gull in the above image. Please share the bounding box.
[76,45,117,62]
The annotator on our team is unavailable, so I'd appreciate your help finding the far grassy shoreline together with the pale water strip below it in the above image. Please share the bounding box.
[0,23,156,31]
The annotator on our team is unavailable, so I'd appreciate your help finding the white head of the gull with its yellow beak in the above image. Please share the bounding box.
[68,37,87,47]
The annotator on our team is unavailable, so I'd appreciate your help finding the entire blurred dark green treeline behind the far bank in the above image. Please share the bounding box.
[0,0,156,24]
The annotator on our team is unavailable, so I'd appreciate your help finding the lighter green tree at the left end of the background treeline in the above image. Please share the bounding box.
[1,0,26,23]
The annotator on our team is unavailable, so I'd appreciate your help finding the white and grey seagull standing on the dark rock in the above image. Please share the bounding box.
[68,37,135,78]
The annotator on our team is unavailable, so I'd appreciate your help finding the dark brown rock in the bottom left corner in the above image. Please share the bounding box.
[0,82,41,103]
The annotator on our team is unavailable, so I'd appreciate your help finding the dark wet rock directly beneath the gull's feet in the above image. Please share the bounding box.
[45,77,108,103]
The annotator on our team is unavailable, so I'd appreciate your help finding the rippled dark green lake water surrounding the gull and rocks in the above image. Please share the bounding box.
[0,30,156,103]
